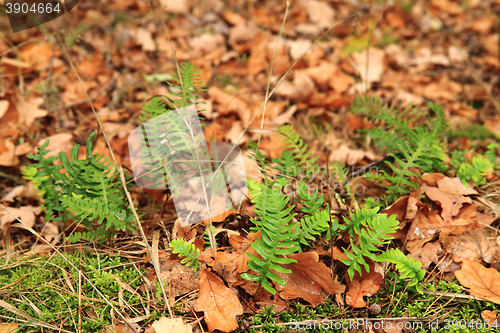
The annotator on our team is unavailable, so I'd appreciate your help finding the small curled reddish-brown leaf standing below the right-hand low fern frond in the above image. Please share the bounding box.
[345,259,383,308]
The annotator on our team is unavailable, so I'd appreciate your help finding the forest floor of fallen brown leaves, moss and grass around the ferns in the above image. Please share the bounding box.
[0,0,500,333]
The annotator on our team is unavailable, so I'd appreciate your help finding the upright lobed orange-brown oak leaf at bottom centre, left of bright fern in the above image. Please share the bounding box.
[194,268,243,332]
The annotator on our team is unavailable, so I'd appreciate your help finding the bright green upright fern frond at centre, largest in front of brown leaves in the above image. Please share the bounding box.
[241,187,298,294]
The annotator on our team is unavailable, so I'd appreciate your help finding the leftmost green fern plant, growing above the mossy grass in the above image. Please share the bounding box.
[23,132,134,242]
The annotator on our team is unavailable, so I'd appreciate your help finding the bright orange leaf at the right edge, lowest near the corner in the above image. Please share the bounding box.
[455,259,500,304]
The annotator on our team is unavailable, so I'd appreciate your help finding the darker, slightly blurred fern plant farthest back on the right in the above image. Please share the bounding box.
[351,97,449,202]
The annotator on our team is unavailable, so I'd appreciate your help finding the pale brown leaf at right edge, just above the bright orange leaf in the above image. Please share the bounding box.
[443,228,500,263]
